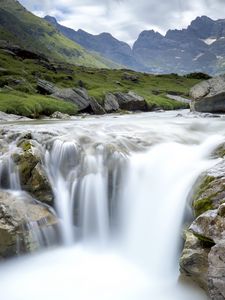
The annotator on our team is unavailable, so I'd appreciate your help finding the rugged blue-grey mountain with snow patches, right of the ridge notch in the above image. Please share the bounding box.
[132,16,225,74]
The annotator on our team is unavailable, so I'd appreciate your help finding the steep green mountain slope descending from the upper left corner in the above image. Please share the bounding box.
[0,0,116,68]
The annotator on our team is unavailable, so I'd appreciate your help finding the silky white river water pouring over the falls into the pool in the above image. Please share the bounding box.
[0,112,225,300]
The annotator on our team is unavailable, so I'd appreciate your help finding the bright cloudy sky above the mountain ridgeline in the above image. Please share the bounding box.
[20,0,225,44]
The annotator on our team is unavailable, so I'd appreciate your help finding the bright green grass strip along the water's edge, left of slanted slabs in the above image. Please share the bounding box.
[0,91,77,118]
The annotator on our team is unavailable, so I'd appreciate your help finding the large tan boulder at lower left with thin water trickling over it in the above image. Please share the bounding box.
[0,191,58,258]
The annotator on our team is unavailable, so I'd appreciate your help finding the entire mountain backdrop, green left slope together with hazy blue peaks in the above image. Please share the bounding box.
[0,0,225,75]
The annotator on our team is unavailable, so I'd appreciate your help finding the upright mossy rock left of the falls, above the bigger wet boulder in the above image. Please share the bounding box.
[13,140,54,205]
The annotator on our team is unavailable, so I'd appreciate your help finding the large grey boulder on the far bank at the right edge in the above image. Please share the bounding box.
[190,75,225,113]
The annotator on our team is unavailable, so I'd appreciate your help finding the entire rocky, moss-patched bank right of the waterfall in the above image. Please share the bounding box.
[180,146,225,300]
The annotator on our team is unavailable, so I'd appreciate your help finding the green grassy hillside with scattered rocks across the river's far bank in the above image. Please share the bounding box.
[0,49,202,116]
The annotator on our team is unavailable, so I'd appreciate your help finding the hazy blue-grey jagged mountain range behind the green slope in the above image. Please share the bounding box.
[45,16,225,74]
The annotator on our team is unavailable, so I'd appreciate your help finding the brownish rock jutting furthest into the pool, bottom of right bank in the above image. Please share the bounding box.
[180,230,210,290]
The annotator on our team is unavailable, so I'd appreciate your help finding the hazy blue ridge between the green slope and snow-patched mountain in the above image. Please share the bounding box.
[44,16,144,69]
